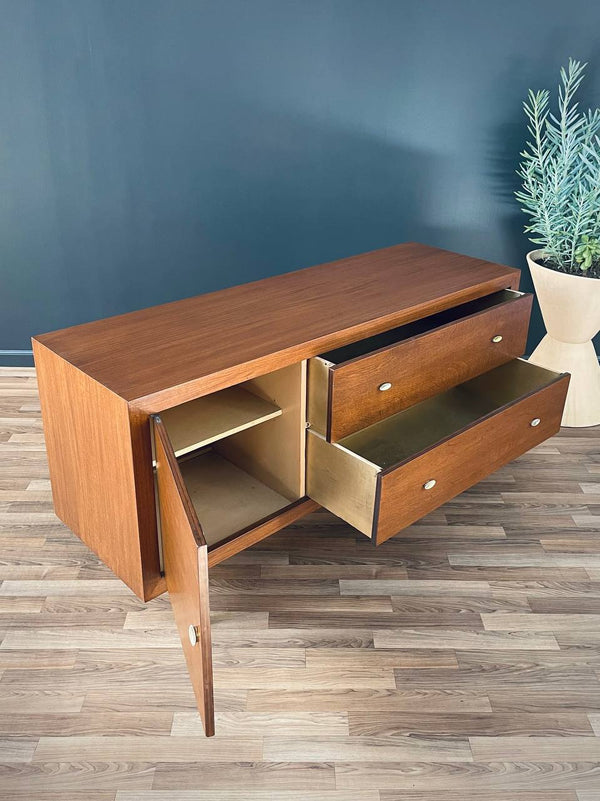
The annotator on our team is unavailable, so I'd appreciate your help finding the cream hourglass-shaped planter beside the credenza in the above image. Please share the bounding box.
[527,250,600,427]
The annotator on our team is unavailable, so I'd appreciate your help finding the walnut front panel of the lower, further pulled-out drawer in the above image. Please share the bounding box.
[373,375,569,544]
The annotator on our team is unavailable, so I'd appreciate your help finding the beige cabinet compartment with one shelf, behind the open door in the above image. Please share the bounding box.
[161,362,306,548]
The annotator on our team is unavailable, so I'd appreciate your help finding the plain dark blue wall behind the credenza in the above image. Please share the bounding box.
[0,0,600,362]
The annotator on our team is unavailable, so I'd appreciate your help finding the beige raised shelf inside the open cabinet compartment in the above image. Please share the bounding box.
[160,386,282,456]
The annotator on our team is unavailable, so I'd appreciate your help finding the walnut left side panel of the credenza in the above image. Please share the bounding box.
[33,340,158,598]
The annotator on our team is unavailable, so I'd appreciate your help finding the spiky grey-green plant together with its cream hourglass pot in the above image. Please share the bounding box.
[515,59,600,426]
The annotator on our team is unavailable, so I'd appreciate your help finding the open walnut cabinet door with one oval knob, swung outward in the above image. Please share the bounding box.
[153,415,215,737]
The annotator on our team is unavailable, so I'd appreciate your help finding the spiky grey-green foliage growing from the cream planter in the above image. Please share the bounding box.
[515,59,600,277]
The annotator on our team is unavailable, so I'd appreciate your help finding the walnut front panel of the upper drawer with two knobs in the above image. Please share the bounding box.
[326,295,532,442]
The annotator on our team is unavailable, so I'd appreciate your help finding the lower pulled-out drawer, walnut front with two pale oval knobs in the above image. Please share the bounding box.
[307,359,569,544]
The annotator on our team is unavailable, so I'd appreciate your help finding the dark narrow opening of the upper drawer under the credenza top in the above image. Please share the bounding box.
[321,289,523,364]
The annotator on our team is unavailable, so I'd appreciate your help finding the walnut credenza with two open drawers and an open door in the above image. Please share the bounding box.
[33,243,569,735]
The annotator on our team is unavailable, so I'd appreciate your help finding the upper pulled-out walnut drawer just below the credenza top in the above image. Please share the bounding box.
[308,289,532,442]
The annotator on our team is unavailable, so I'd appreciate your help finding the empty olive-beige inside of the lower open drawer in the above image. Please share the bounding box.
[337,359,558,470]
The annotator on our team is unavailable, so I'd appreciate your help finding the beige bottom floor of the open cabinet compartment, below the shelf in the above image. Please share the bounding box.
[179,449,292,546]
